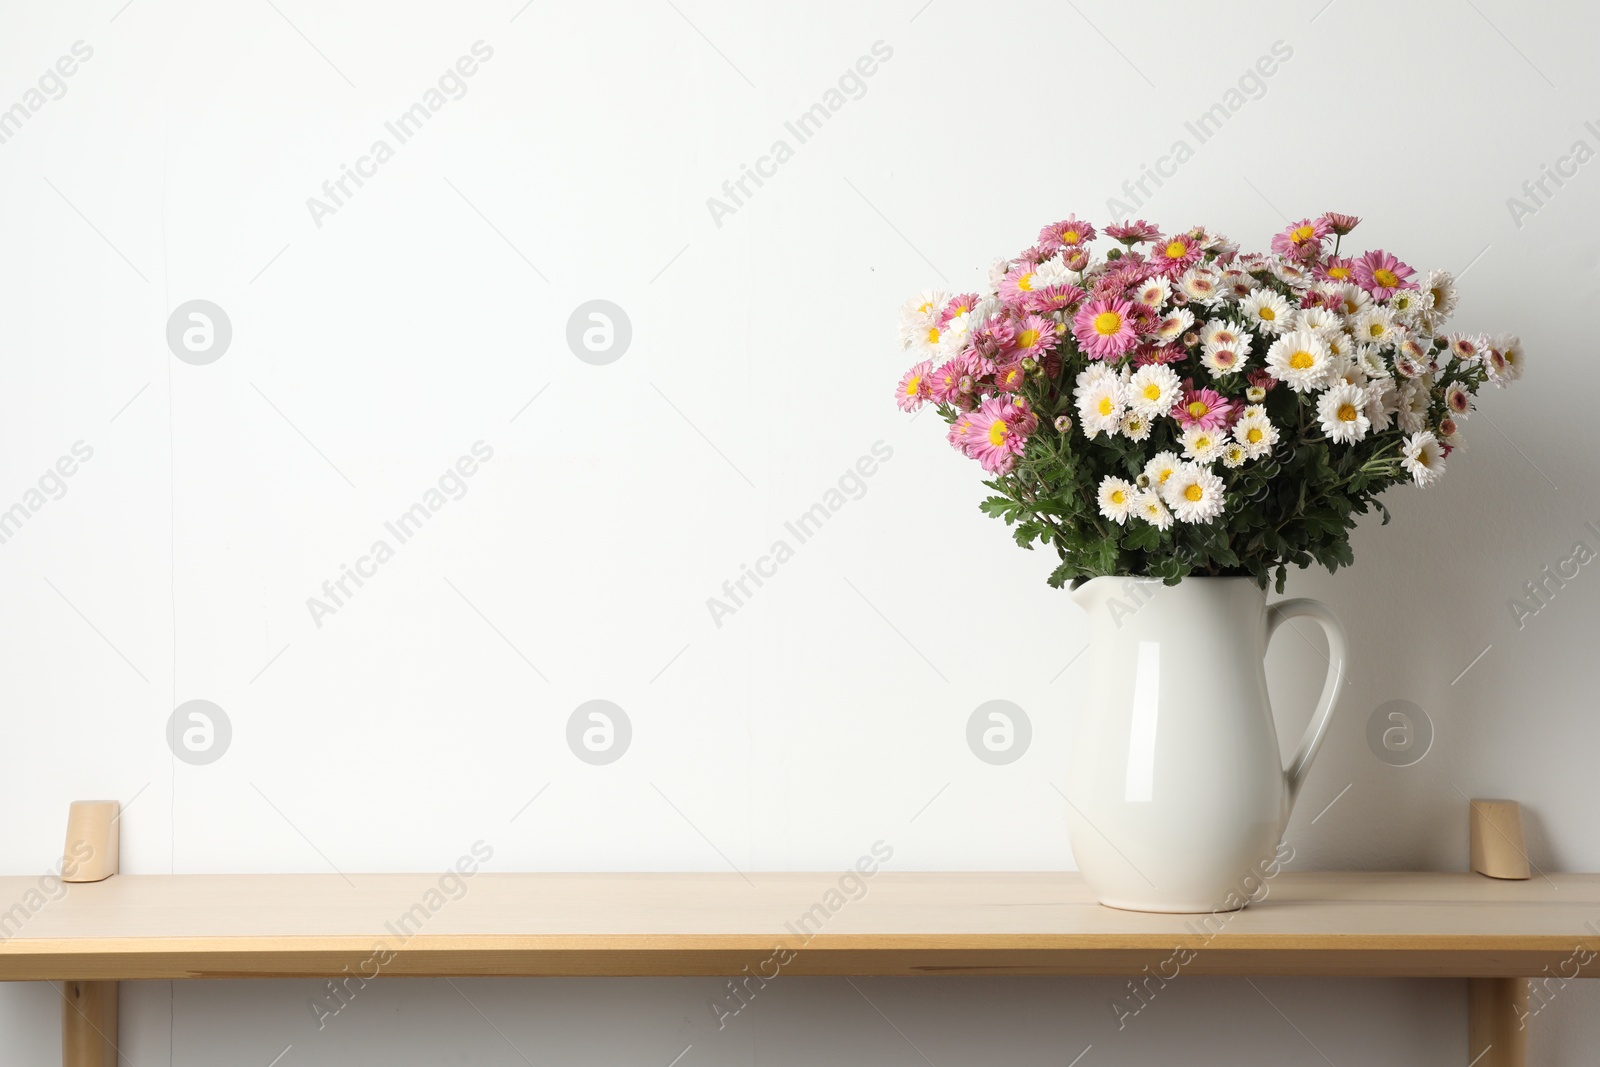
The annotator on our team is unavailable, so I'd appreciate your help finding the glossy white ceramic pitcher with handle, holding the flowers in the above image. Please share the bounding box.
[1066,577,1347,912]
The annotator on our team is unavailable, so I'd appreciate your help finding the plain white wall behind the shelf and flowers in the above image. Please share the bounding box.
[0,0,1600,1067]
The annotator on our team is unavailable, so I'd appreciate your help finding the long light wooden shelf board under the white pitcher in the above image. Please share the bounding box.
[0,872,1600,981]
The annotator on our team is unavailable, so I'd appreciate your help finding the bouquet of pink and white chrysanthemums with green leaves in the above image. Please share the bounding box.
[898,213,1525,590]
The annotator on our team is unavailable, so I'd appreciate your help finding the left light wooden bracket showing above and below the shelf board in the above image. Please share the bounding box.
[61,800,122,1067]
